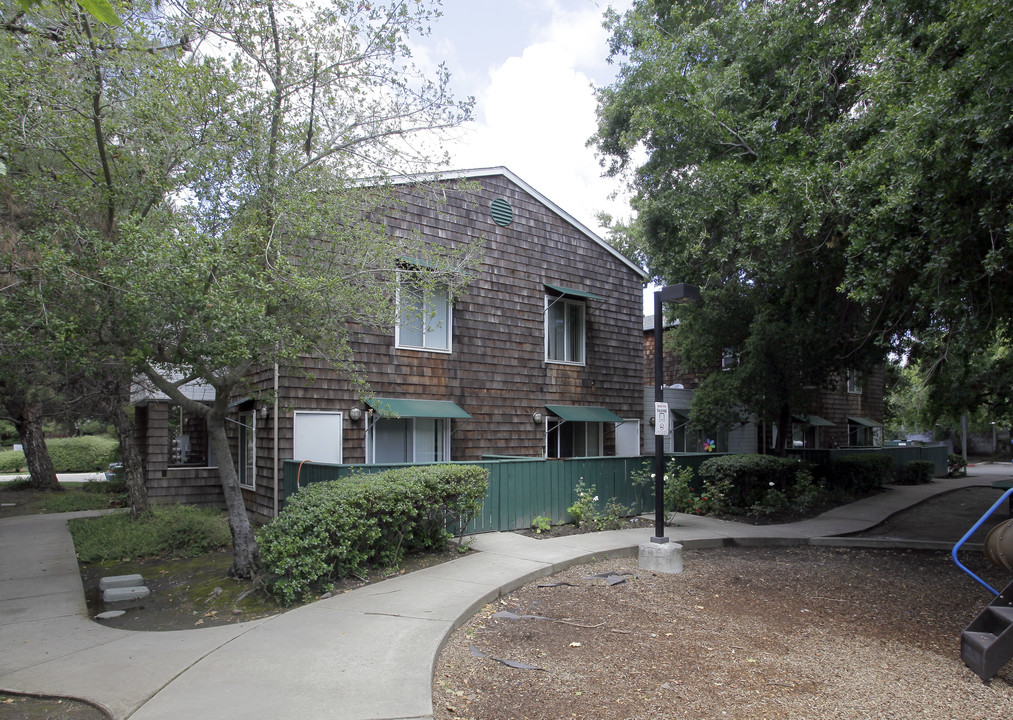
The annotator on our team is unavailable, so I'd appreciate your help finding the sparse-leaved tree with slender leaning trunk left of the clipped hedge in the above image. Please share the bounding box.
[4,0,471,577]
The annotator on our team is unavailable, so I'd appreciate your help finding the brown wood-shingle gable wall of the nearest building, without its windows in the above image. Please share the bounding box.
[227,168,644,518]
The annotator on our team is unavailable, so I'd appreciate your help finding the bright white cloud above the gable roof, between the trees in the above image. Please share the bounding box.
[431,1,629,236]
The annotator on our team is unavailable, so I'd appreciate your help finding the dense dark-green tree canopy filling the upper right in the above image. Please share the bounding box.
[593,0,1013,439]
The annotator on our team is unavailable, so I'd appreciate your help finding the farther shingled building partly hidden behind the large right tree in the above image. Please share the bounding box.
[643,315,883,454]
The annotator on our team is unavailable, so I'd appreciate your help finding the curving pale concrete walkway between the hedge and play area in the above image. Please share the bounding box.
[0,465,1013,720]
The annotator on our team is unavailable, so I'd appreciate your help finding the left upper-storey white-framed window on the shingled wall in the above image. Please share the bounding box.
[394,270,453,352]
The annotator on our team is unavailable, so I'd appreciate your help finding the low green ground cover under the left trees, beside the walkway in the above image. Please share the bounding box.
[70,505,232,562]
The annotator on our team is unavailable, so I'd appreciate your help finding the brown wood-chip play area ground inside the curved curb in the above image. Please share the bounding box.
[434,547,1013,720]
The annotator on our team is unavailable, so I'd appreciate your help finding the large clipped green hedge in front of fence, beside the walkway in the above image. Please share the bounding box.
[258,465,488,605]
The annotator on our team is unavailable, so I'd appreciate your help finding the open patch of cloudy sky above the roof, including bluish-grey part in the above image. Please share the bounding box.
[416,0,630,242]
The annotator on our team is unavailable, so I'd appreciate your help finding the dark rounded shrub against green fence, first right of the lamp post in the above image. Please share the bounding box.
[700,455,799,512]
